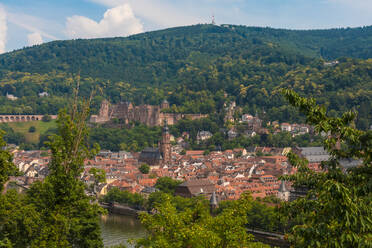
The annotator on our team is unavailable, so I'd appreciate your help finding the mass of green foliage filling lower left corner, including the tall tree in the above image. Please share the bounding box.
[0,105,103,248]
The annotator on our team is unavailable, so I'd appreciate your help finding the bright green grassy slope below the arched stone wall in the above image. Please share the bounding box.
[7,120,57,144]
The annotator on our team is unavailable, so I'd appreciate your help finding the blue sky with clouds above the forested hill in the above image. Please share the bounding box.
[0,0,372,54]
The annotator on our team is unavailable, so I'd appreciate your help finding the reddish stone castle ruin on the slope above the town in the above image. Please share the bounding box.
[90,100,207,127]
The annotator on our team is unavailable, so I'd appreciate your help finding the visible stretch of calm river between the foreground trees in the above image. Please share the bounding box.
[101,214,146,247]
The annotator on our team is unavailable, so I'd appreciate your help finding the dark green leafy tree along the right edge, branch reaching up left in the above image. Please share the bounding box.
[281,90,372,247]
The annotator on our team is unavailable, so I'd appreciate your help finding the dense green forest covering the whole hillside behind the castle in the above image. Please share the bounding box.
[0,25,372,129]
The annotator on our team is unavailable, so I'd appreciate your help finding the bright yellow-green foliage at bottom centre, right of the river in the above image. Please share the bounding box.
[137,194,268,248]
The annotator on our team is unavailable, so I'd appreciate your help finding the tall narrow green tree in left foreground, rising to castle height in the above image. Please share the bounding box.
[26,101,103,247]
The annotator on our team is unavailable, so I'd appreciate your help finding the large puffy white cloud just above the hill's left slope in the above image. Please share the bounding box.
[65,4,143,38]
